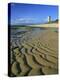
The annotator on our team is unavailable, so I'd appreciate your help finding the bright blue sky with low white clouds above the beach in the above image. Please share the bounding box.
[10,3,58,25]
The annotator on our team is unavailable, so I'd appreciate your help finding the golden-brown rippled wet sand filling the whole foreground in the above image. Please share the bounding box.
[10,28,58,76]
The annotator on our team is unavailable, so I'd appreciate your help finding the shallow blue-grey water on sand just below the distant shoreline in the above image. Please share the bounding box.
[11,27,45,38]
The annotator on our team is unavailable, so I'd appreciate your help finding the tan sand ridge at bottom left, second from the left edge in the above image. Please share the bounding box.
[14,48,31,76]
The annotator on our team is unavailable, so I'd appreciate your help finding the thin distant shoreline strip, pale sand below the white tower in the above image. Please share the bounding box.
[8,22,59,27]
